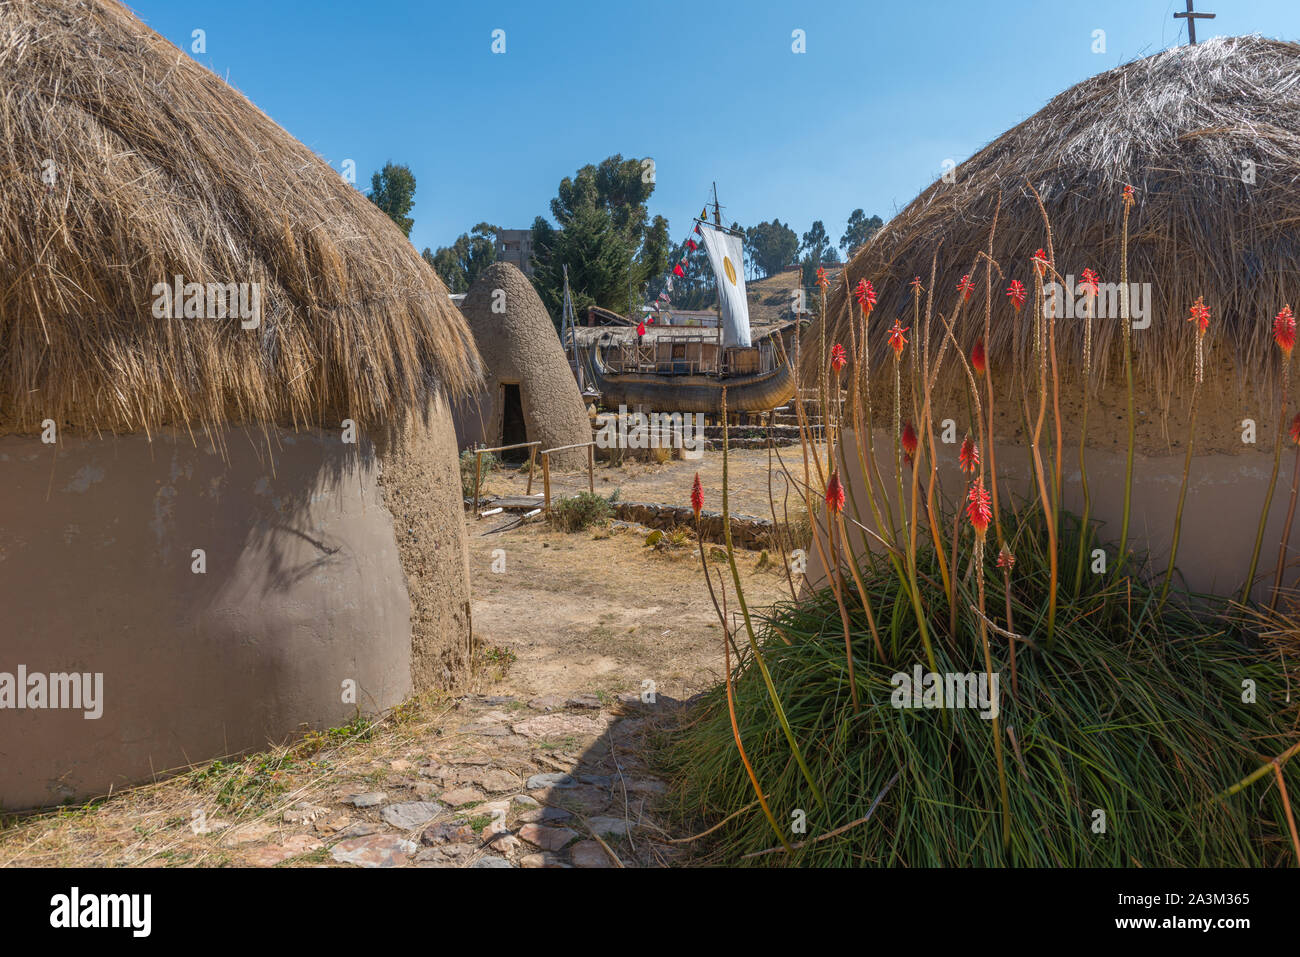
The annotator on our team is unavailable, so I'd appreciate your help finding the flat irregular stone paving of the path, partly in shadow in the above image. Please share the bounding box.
[222,694,683,867]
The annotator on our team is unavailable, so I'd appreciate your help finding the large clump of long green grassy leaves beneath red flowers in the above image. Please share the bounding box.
[662,511,1300,867]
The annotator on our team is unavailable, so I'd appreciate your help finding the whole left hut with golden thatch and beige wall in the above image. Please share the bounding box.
[0,0,478,807]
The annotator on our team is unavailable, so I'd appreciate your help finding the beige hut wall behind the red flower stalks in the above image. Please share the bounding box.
[809,430,1300,596]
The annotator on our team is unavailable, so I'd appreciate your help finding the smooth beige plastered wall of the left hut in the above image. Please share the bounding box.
[0,426,413,809]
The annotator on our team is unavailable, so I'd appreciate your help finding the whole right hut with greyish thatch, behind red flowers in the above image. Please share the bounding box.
[803,36,1300,594]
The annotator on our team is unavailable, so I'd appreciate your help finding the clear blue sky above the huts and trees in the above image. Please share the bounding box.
[126,0,1300,257]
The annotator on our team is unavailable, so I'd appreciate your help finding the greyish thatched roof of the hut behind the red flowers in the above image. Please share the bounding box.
[806,36,1300,403]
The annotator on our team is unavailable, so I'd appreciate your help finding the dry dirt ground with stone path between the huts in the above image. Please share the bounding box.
[0,452,789,867]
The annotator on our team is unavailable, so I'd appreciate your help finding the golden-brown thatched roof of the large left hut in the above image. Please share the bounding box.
[0,0,478,433]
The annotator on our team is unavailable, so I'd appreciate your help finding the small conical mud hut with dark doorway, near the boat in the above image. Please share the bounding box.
[456,263,592,468]
